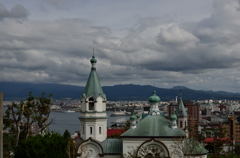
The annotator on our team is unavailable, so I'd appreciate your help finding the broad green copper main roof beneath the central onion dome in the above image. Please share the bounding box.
[121,115,186,137]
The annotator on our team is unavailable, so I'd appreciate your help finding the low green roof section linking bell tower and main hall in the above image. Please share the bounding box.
[101,138,123,154]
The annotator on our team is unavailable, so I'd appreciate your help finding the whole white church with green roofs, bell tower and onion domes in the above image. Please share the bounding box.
[78,56,208,158]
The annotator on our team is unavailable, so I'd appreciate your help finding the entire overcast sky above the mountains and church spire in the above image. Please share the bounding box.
[0,0,240,92]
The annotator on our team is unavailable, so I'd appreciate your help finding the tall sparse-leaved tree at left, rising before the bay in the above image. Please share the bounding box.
[3,92,53,146]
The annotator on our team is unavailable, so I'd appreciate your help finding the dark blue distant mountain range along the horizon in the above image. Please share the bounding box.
[0,82,240,101]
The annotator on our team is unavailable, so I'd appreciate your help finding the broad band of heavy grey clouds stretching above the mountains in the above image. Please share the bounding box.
[0,0,240,91]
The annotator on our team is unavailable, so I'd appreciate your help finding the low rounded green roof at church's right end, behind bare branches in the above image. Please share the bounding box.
[184,138,208,156]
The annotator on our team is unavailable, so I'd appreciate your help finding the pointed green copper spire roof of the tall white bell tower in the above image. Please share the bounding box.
[82,56,106,99]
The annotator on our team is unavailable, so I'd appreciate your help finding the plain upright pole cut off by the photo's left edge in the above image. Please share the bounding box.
[0,92,3,158]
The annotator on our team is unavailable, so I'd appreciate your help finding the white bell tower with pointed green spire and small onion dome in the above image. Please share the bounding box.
[79,55,107,142]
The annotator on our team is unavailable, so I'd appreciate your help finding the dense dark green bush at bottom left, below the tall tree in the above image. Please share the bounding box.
[14,132,68,158]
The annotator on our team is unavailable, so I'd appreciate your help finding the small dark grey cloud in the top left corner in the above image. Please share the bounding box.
[0,3,29,20]
